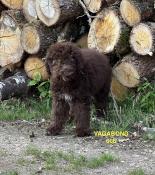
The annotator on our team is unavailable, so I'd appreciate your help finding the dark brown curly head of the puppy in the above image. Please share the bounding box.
[46,43,80,82]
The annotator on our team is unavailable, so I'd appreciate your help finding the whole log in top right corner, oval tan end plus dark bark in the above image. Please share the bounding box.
[120,0,154,26]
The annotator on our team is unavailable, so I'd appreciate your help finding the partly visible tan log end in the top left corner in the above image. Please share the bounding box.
[1,0,23,9]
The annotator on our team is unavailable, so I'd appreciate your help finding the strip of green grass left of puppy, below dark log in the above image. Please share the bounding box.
[0,98,51,121]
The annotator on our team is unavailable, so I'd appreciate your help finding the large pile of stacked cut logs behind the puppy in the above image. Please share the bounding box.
[0,0,155,100]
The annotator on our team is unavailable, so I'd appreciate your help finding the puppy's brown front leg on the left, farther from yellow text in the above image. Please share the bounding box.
[47,97,69,135]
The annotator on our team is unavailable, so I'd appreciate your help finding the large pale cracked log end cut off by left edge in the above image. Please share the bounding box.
[0,14,24,67]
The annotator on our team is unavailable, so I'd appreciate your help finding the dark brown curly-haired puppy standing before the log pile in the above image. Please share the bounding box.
[46,43,111,136]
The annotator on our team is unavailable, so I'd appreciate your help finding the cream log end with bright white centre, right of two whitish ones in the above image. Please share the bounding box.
[36,0,61,26]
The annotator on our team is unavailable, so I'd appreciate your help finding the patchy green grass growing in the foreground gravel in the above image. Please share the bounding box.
[26,147,119,172]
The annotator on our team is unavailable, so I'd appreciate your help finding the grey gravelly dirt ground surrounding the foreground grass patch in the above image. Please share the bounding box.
[0,122,155,175]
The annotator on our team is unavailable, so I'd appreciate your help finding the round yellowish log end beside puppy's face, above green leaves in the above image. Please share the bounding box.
[24,56,49,80]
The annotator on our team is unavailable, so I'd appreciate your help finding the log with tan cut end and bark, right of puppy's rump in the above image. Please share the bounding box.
[113,54,155,88]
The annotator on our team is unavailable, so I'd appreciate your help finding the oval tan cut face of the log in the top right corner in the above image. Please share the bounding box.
[120,0,141,26]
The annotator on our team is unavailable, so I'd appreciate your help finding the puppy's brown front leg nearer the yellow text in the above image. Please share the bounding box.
[72,102,91,137]
